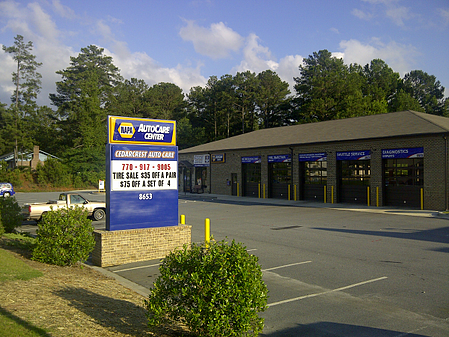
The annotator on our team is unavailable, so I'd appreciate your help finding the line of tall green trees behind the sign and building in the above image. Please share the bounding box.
[0,35,449,186]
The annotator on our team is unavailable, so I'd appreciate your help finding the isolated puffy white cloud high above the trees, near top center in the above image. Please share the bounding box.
[179,21,244,59]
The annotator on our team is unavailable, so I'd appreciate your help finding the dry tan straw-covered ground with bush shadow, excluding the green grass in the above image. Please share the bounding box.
[0,246,189,337]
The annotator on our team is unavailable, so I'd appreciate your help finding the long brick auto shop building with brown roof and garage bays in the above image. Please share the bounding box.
[178,111,449,210]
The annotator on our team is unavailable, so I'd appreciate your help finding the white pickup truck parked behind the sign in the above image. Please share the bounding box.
[22,193,106,221]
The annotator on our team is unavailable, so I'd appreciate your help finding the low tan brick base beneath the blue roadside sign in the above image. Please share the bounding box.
[92,225,192,267]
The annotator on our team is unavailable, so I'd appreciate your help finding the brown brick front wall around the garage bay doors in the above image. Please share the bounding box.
[179,134,449,210]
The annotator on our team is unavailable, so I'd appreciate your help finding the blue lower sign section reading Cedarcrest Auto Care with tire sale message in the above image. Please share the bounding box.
[106,140,178,231]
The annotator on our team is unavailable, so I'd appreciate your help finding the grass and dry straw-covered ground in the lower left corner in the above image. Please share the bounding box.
[0,234,184,337]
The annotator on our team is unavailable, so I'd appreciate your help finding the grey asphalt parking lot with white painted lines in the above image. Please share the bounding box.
[14,195,449,337]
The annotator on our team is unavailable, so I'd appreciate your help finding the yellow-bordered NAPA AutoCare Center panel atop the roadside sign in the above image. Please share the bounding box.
[109,116,176,145]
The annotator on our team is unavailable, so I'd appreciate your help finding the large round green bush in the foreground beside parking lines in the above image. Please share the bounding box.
[145,241,268,336]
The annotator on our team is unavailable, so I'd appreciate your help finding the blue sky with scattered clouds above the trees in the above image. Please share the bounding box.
[0,0,449,108]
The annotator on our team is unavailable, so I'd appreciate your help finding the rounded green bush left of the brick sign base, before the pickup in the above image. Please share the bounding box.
[33,207,95,266]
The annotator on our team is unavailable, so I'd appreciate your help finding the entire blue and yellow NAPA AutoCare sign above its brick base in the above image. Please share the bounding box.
[106,116,178,231]
